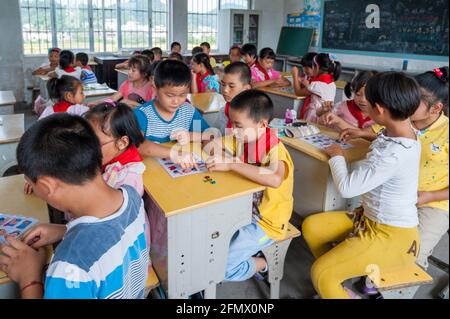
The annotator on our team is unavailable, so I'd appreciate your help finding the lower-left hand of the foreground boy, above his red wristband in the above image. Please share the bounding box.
[0,236,47,288]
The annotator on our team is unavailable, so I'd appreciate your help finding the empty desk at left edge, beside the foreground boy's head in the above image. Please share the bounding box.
[0,114,25,177]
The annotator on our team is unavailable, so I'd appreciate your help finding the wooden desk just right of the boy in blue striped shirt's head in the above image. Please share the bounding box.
[188,93,226,129]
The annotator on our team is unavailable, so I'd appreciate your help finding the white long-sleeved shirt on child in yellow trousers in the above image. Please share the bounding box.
[329,132,421,228]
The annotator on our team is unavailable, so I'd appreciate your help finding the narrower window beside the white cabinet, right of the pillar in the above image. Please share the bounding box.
[188,0,251,50]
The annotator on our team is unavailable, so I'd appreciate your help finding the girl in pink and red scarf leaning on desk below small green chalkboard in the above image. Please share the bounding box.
[251,48,291,88]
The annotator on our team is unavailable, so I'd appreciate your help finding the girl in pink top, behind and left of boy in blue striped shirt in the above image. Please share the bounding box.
[89,55,153,108]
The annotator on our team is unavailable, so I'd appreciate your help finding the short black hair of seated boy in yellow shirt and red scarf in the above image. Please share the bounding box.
[230,89,274,123]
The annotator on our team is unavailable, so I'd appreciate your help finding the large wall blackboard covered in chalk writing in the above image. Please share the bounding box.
[321,0,449,56]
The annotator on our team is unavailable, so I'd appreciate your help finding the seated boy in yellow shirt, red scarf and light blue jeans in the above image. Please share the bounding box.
[207,90,294,281]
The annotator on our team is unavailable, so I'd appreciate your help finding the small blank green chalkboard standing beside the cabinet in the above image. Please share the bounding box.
[277,27,314,57]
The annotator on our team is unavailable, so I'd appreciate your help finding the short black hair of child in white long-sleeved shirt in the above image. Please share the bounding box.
[366,72,421,121]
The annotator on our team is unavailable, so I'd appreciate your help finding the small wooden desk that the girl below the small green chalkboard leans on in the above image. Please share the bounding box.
[259,87,305,118]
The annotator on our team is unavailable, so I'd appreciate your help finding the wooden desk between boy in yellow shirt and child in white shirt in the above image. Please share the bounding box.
[281,126,370,217]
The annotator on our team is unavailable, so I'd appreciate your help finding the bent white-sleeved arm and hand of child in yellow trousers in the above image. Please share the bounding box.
[325,144,398,198]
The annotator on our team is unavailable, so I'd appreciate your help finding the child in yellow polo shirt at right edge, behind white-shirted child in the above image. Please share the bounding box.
[341,67,449,293]
